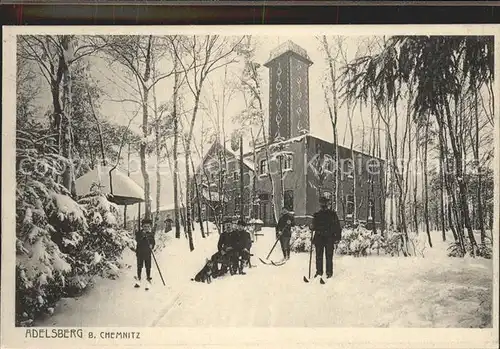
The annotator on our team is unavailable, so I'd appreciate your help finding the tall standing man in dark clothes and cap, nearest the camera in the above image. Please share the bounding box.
[312,196,342,279]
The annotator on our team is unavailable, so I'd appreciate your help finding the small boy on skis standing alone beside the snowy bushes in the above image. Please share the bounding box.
[135,218,155,290]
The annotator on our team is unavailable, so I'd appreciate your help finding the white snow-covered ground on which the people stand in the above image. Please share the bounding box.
[37,224,493,327]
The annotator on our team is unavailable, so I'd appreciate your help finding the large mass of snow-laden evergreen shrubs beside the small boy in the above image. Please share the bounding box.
[16,150,131,326]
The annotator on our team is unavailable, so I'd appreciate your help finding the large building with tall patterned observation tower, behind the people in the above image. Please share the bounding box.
[195,41,384,225]
